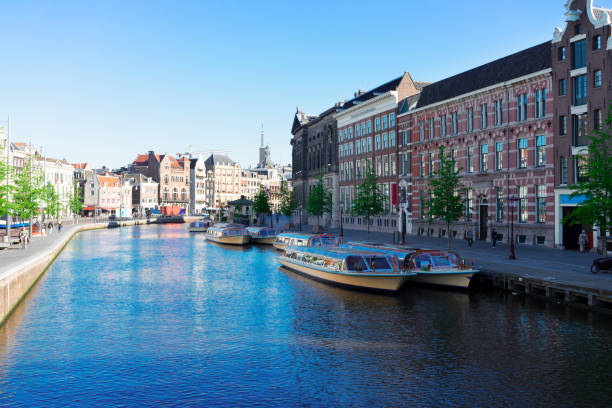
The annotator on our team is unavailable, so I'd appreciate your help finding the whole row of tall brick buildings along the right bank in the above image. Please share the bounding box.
[291,0,612,248]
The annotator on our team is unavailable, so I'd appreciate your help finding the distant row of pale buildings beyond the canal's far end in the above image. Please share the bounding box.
[0,131,291,217]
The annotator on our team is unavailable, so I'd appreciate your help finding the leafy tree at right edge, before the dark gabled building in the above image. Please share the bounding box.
[563,105,612,255]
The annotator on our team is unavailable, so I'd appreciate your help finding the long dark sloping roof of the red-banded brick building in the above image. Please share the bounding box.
[416,41,552,108]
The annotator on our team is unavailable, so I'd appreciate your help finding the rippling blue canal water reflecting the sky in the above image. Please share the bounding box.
[0,225,612,407]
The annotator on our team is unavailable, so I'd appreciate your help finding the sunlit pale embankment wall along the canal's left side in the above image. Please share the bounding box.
[0,220,146,325]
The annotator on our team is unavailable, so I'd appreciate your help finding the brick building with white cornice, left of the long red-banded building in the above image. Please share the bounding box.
[334,72,424,231]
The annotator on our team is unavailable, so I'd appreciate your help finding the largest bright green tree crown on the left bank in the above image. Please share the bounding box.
[10,161,42,220]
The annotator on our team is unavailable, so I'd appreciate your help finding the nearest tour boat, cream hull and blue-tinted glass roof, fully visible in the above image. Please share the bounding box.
[278,246,416,292]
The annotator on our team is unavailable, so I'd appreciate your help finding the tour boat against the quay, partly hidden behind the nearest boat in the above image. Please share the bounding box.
[342,242,479,289]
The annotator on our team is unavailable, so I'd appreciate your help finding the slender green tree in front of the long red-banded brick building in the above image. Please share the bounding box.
[427,146,466,251]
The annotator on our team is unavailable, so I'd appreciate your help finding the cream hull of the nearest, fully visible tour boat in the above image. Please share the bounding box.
[279,256,409,292]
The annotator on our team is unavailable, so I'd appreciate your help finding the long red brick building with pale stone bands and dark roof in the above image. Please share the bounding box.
[398,42,555,246]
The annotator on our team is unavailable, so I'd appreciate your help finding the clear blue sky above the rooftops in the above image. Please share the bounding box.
[0,0,568,167]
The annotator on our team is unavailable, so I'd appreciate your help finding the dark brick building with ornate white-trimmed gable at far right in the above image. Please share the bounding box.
[552,0,612,249]
